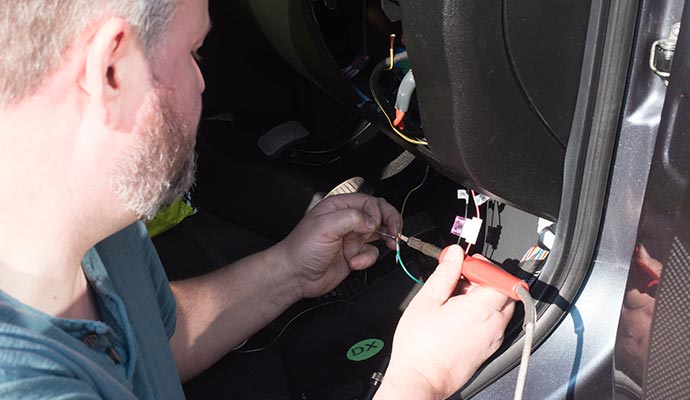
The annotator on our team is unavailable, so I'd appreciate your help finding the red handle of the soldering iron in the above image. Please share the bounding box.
[439,247,529,301]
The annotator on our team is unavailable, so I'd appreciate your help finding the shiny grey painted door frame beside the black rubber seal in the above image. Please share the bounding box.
[476,1,682,399]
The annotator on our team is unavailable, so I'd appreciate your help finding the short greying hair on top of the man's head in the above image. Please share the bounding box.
[0,0,179,106]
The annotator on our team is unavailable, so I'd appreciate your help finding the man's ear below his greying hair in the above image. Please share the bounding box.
[80,17,147,126]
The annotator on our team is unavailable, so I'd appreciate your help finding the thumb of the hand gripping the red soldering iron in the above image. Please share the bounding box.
[418,244,465,304]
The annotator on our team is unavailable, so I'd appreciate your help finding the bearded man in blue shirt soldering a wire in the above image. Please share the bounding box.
[0,0,513,399]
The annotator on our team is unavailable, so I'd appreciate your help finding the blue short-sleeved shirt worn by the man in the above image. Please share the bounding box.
[0,222,184,400]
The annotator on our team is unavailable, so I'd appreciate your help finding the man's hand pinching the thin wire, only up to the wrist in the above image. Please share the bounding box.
[276,194,400,298]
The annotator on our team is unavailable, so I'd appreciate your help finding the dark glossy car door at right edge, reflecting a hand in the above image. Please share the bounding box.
[614,0,690,399]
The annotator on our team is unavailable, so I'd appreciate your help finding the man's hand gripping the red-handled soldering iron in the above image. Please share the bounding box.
[376,245,514,400]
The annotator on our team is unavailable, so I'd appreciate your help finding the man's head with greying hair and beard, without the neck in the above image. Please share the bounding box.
[0,0,210,222]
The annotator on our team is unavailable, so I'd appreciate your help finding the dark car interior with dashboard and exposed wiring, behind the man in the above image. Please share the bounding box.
[153,0,635,400]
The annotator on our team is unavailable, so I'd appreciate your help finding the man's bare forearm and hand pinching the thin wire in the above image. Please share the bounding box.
[170,194,400,381]
